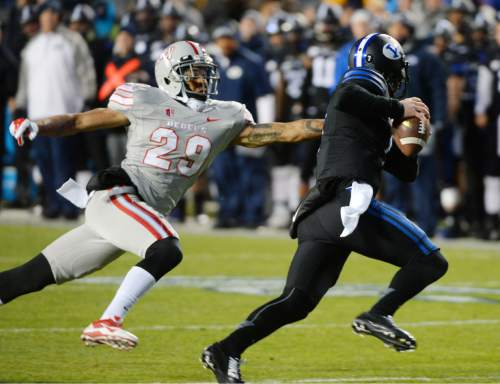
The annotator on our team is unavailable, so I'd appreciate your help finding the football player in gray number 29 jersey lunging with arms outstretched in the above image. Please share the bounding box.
[0,41,323,349]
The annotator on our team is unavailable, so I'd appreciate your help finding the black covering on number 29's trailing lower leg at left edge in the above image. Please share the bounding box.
[0,253,56,303]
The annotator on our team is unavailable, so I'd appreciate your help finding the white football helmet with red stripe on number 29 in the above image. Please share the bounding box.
[155,40,219,103]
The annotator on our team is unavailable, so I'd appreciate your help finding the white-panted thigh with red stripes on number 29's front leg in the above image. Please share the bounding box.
[85,191,179,257]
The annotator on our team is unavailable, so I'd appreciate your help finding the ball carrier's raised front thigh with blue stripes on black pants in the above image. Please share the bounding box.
[344,200,439,267]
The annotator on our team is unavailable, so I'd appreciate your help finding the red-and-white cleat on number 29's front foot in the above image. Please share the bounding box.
[80,319,139,350]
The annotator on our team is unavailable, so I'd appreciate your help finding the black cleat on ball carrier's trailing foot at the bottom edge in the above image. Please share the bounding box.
[201,343,244,383]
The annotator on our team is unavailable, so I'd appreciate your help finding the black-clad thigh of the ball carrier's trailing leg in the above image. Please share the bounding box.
[286,241,350,304]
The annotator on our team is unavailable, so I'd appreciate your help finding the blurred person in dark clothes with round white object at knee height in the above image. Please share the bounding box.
[434,1,485,238]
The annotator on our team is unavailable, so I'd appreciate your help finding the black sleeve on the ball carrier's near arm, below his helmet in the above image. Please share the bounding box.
[333,82,404,120]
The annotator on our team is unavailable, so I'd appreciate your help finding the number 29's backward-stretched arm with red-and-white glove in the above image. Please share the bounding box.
[9,108,130,145]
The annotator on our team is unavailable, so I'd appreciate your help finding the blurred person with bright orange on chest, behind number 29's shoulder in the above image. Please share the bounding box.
[97,27,151,165]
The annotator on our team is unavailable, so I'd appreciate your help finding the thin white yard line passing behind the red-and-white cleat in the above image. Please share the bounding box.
[0,319,500,333]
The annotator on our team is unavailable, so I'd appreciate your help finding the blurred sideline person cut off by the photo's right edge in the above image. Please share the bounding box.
[475,21,500,240]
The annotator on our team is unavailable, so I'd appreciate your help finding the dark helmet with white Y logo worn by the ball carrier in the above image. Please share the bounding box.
[349,33,408,96]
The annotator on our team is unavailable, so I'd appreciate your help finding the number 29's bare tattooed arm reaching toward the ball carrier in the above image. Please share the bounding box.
[233,119,324,147]
